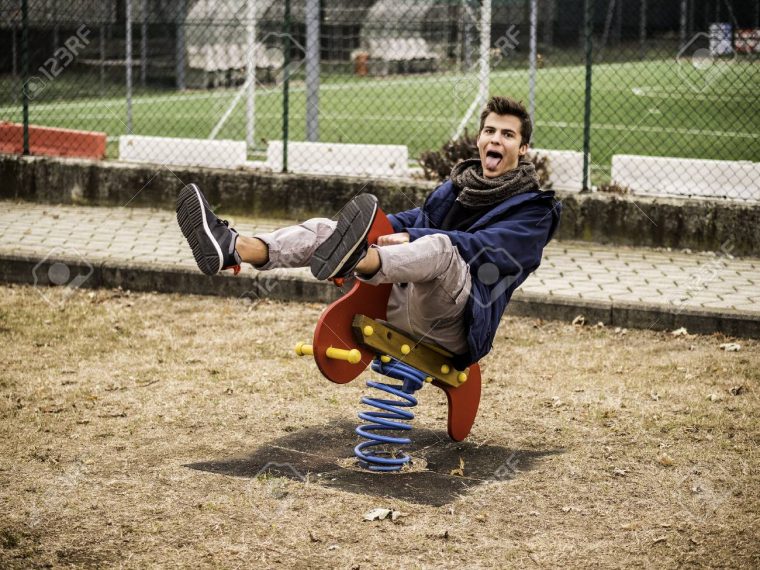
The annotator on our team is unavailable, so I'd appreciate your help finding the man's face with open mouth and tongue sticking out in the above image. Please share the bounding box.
[478,113,528,178]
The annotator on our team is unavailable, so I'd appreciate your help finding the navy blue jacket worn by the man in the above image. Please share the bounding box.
[388,180,562,363]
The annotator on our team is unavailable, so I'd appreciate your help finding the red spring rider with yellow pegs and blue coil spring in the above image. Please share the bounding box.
[295,202,480,471]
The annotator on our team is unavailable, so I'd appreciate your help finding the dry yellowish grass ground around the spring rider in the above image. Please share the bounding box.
[0,286,760,568]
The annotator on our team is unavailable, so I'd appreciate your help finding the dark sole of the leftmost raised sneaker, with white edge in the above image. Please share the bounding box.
[177,184,223,275]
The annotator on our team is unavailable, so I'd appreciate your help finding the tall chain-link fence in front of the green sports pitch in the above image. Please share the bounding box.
[0,0,760,200]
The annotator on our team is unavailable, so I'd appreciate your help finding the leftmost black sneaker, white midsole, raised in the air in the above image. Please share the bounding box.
[177,184,240,275]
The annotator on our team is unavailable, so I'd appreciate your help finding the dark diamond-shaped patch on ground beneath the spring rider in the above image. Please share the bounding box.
[186,421,560,506]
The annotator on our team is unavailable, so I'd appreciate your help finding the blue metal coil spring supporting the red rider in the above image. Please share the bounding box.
[354,358,426,471]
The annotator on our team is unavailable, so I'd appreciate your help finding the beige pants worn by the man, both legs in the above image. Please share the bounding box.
[254,218,472,354]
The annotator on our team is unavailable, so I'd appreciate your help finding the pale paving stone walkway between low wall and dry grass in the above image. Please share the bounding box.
[0,202,760,324]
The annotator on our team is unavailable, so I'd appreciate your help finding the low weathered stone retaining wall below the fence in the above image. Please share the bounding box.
[0,155,760,257]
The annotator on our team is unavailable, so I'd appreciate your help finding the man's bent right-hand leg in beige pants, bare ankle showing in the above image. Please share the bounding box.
[357,234,472,354]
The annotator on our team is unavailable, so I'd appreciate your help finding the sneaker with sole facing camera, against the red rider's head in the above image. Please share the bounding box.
[311,194,377,280]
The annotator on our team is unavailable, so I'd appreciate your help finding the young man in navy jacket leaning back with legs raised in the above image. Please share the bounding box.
[177,97,561,367]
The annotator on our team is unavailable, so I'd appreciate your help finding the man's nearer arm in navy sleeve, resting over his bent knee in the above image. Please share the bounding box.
[405,205,552,275]
